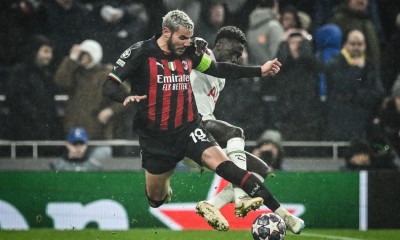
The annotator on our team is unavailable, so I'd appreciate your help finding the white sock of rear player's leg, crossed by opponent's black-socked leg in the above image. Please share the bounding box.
[226,137,248,203]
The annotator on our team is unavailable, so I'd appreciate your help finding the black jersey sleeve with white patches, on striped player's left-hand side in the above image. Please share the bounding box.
[108,42,143,84]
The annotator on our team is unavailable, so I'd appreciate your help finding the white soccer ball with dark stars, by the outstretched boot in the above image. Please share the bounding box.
[251,213,286,240]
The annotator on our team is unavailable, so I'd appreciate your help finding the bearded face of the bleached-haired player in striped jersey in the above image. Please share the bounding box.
[167,26,193,56]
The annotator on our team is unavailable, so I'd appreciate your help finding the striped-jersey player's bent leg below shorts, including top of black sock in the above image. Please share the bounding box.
[145,170,174,208]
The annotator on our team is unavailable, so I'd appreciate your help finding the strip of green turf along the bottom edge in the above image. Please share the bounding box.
[0,229,400,240]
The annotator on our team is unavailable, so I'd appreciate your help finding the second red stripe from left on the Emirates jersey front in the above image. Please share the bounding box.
[160,59,172,130]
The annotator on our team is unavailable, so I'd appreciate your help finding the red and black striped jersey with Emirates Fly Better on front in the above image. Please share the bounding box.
[109,35,211,133]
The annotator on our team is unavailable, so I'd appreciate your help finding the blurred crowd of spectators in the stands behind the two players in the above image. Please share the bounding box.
[0,0,400,169]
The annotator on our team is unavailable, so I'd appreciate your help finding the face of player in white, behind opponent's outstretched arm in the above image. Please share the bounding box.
[215,40,244,64]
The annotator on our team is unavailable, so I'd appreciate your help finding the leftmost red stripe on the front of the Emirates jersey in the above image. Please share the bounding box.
[148,57,158,123]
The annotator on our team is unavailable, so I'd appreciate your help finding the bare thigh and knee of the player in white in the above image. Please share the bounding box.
[204,119,244,146]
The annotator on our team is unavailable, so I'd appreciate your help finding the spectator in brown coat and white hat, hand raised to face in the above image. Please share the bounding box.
[54,40,122,158]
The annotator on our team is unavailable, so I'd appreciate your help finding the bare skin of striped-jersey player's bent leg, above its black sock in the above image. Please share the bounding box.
[145,170,174,200]
